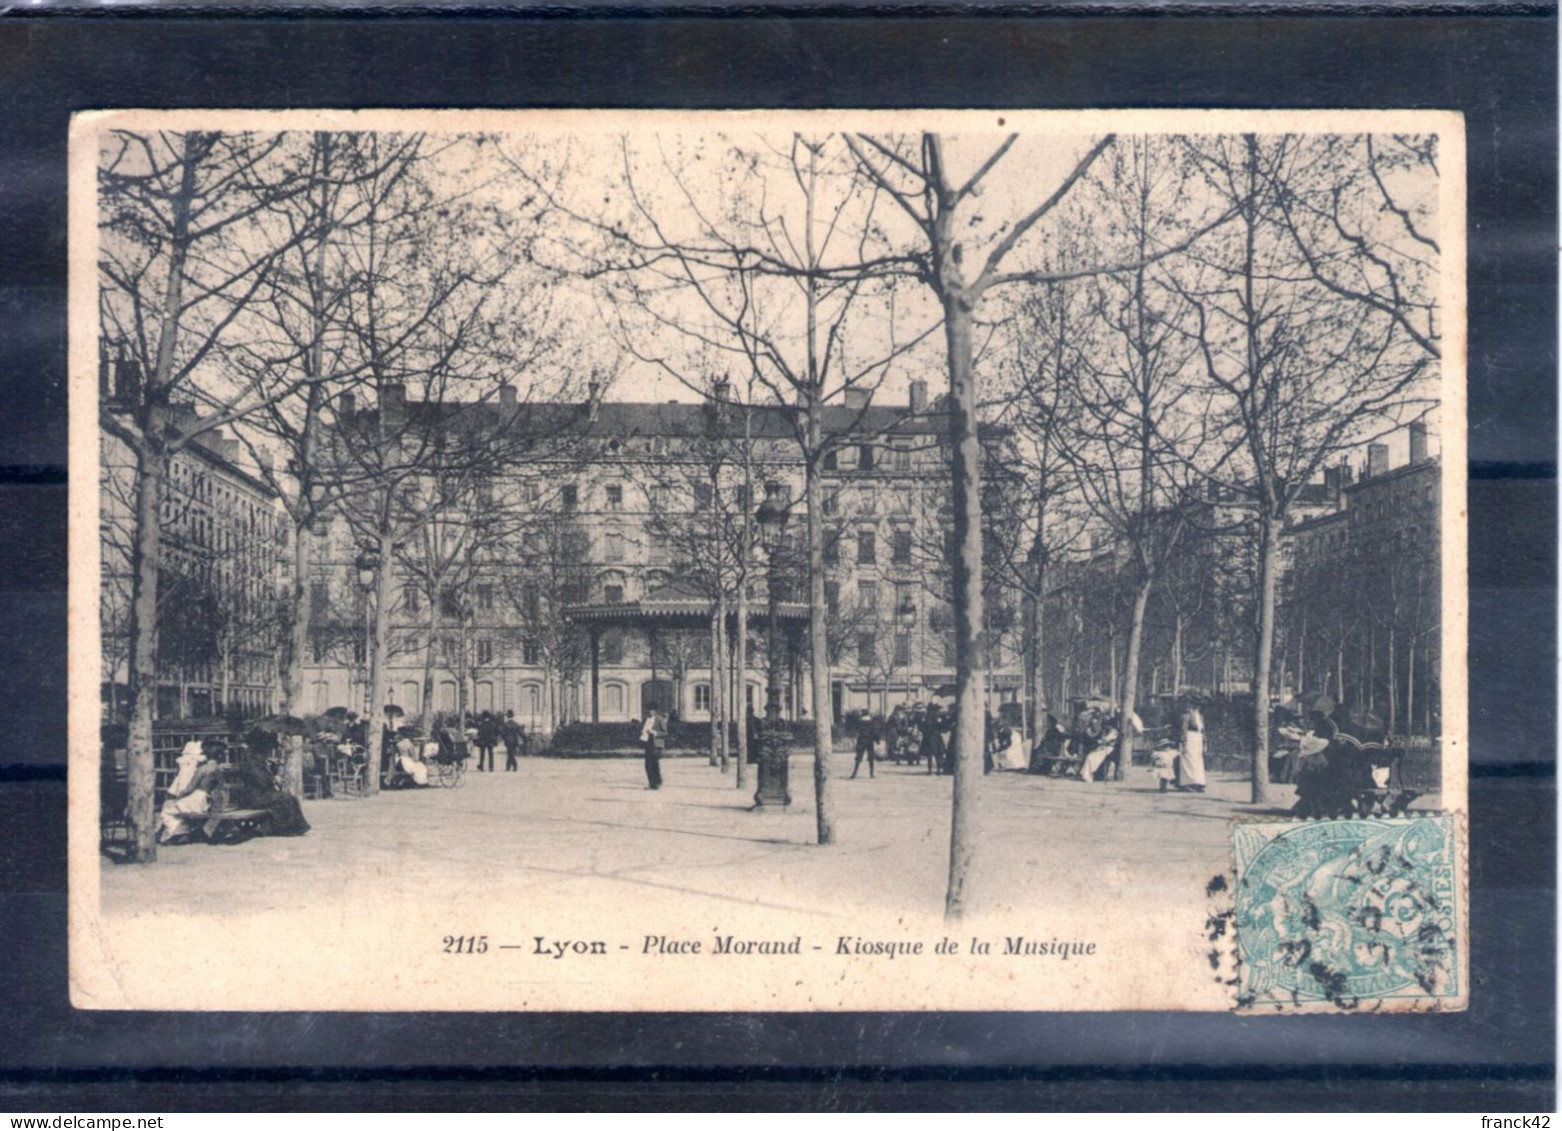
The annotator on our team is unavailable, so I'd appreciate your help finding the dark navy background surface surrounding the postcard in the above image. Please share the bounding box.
[0,14,1557,1112]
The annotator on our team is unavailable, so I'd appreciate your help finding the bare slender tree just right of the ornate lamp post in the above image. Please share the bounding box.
[540,134,929,844]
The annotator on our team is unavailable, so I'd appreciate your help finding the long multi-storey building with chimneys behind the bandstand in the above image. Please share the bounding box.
[305,383,1018,733]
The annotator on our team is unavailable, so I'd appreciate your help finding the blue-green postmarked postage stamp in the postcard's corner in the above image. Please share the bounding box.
[1232,812,1468,1012]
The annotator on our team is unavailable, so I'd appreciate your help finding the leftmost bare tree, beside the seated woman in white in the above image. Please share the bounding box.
[98,130,329,862]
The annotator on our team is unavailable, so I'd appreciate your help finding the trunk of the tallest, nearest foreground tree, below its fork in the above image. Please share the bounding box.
[943,289,987,922]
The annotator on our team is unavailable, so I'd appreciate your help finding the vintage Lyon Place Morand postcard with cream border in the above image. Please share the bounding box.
[70,109,1468,1015]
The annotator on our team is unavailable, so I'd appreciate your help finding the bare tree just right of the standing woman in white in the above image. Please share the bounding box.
[1181,134,1437,803]
